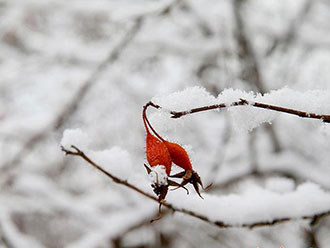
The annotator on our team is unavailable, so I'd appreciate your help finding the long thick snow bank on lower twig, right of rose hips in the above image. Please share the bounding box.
[167,183,330,225]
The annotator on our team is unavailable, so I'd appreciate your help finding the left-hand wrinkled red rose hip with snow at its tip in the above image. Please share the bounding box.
[146,130,172,175]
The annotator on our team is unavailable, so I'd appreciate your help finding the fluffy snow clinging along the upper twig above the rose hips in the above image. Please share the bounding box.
[150,87,330,132]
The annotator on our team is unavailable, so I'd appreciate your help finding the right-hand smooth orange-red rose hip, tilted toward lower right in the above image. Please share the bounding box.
[164,140,192,171]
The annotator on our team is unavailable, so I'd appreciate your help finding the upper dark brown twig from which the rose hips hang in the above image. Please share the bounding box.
[149,99,330,123]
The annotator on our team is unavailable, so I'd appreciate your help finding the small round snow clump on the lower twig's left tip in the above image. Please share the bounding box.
[61,128,90,149]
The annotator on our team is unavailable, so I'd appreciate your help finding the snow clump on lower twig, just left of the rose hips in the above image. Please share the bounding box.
[88,147,132,180]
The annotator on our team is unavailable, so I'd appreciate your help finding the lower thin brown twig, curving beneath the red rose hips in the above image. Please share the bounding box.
[62,146,330,229]
